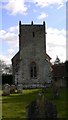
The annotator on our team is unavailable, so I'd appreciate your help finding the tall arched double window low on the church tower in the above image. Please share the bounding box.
[30,62,37,78]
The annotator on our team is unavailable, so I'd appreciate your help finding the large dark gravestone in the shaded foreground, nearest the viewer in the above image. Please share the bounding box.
[26,94,57,120]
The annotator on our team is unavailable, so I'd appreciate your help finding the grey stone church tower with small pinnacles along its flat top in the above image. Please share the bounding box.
[12,21,51,86]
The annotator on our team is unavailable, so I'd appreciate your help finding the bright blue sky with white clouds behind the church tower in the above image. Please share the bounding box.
[0,0,67,64]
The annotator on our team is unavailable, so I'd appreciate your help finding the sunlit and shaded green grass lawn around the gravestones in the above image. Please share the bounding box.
[2,88,68,120]
